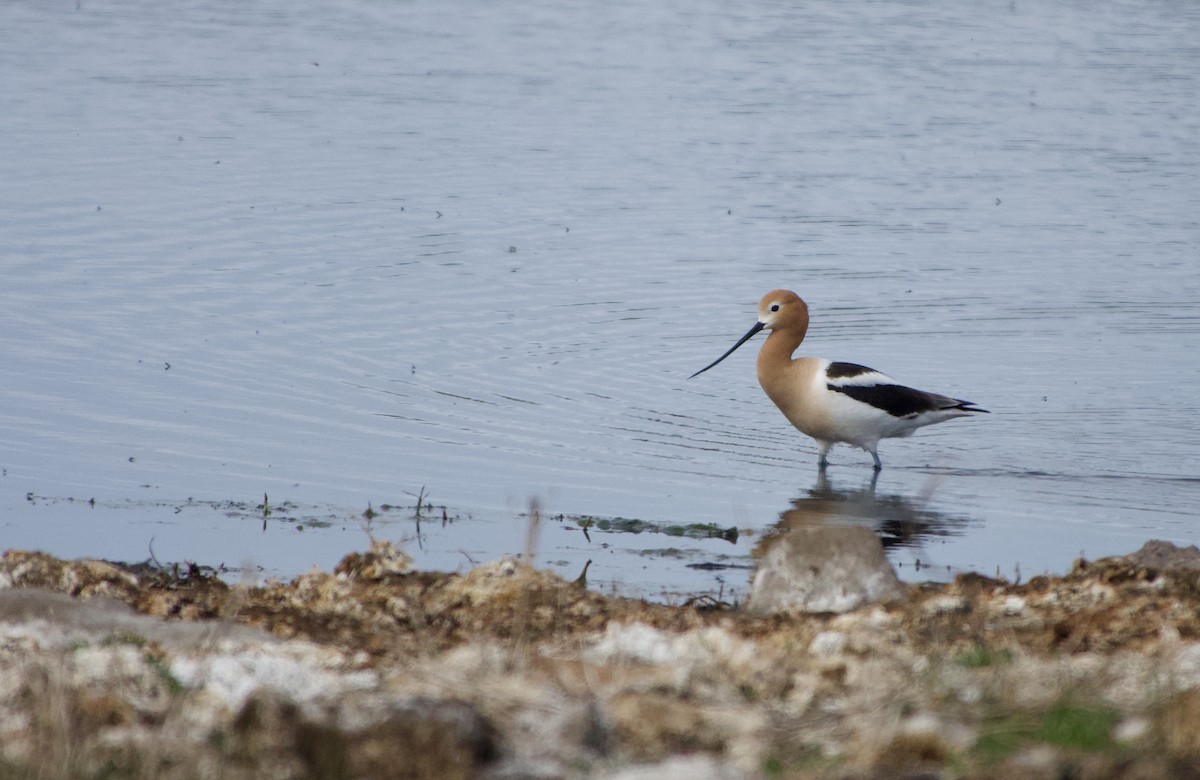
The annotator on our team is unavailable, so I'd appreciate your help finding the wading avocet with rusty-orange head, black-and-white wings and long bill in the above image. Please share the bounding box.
[689,289,988,470]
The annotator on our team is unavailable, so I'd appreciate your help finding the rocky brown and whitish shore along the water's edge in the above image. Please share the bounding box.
[0,542,1200,780]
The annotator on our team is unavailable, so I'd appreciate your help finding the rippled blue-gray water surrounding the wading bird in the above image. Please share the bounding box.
[0,0,1200,598]
